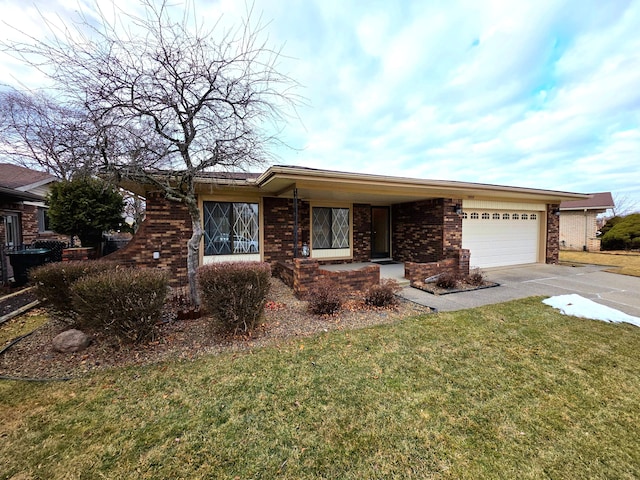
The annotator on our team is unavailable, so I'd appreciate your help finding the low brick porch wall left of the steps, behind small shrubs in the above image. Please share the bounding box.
[272,258,380,297]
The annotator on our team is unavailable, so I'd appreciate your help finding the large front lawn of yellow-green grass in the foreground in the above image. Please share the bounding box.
[0,298,640,479]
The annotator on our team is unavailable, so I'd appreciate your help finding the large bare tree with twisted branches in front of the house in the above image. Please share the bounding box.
[5,0,297,303]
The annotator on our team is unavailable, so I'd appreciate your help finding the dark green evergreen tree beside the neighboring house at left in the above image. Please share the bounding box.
[47,176,124,251]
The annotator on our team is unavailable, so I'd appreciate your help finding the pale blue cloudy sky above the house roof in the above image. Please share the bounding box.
[0,0,640,211]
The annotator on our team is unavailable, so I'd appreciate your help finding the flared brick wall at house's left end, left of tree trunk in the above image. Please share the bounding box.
[103,192,192,286]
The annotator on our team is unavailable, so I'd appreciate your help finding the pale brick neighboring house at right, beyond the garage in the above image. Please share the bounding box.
[560,192,614,252]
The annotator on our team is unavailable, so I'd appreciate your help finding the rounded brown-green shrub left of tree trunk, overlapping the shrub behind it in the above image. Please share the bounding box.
[71,268,169,343]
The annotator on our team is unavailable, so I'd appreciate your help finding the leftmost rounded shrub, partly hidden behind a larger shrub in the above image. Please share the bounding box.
[29,260,117,322]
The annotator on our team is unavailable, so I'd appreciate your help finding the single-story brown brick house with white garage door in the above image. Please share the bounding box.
[113,166,588,284]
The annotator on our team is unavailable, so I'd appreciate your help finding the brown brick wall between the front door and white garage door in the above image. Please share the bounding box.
[391,198,462,263]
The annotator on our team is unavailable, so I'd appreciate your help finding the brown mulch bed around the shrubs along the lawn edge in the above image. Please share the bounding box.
[0,279,431,378]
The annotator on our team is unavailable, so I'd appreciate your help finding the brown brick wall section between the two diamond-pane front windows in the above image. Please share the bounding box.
[262,197,310,264]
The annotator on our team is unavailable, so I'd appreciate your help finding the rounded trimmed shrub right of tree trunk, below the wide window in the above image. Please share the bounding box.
[197,262,271,333]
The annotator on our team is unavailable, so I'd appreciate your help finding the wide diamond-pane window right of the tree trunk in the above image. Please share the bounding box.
[204,202,260,255]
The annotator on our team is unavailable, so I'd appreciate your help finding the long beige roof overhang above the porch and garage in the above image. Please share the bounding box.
[255,165,588,205]
